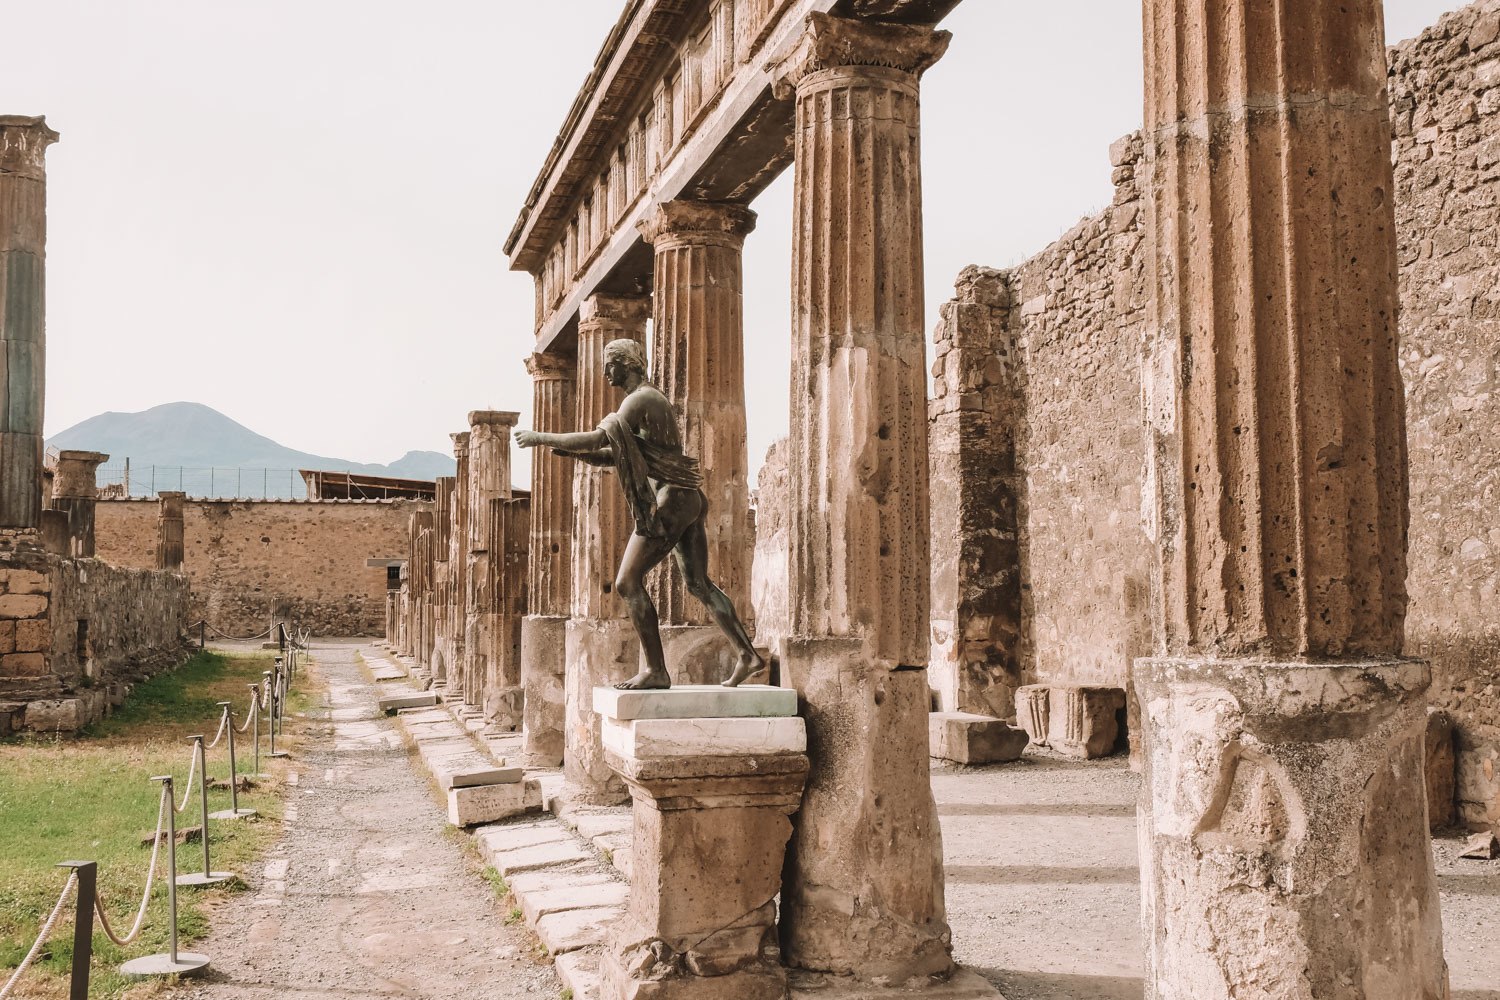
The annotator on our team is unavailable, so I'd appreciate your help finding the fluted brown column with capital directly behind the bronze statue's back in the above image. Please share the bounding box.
[641,201,755,684]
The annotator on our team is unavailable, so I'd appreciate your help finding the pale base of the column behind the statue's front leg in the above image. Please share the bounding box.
[563,618,641,805]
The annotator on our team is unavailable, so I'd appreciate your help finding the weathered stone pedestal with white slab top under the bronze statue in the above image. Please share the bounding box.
[594,687,807,1000]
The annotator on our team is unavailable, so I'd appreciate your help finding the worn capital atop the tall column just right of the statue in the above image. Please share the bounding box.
[768,13,953,100]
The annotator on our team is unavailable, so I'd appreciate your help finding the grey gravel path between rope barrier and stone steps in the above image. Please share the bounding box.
[179,643,560,1000]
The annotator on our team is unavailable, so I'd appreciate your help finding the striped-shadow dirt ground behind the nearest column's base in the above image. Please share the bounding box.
[933,751,1500,1000]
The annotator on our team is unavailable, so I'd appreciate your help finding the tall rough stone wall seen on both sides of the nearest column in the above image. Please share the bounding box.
[932,0,1500,823]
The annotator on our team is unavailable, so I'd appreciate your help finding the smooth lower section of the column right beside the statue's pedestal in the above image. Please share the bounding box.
[782,637,954,982]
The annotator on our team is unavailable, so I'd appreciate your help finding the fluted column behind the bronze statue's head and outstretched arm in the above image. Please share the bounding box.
[564,295,651,804]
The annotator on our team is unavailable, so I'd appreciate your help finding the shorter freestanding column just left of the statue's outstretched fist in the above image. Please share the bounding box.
[464,409,521,733]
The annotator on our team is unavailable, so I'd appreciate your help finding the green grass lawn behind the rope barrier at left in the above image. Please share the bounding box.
[0,652,315,999]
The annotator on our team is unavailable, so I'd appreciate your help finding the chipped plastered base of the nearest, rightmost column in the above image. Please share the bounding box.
[1134,658,1449,1000]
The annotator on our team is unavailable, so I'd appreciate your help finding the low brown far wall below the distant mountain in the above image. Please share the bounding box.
[95,499,431,636]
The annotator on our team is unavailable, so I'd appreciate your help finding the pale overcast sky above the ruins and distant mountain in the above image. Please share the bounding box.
[0,0,1463,484]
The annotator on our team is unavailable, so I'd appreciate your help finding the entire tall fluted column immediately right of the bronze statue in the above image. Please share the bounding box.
[773,13,953,982]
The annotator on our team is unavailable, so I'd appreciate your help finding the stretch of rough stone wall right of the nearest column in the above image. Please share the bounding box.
[1391,0,1500,823]
